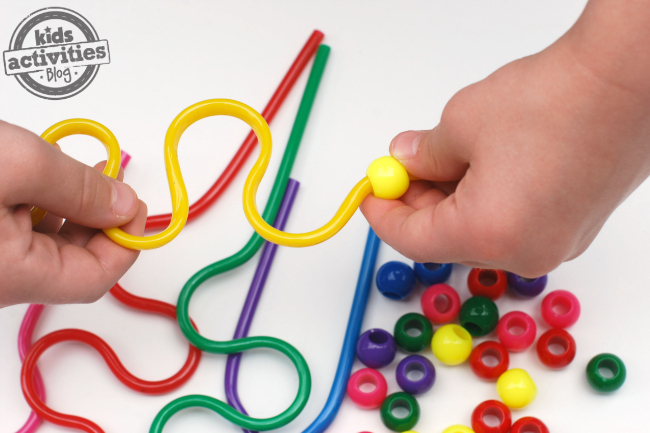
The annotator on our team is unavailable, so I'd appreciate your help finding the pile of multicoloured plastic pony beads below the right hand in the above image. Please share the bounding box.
[348,262,626,433]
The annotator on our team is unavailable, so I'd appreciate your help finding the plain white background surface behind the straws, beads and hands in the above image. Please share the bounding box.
[0,0,650,433]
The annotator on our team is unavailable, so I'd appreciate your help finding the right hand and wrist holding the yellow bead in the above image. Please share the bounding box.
[361,2,650,277]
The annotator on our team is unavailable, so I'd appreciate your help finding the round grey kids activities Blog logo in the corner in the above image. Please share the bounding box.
[3,7,110,99]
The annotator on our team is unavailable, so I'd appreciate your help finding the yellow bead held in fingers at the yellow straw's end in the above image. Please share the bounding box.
[366,156,409,200]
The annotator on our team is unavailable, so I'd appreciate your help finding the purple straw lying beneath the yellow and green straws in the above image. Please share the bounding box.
[226,179,300,433]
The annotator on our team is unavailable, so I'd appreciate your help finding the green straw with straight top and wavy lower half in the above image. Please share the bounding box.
[149,45,329,433]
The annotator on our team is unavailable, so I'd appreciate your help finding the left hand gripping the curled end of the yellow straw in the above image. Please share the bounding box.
[0,121,147,307]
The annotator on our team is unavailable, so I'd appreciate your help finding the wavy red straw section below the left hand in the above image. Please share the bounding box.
[21,284,201,431]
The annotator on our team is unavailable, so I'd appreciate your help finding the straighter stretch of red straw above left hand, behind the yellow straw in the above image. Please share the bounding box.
[145,30,324,230]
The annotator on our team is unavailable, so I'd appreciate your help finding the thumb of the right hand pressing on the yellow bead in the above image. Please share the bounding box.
[390,126,469,182]
